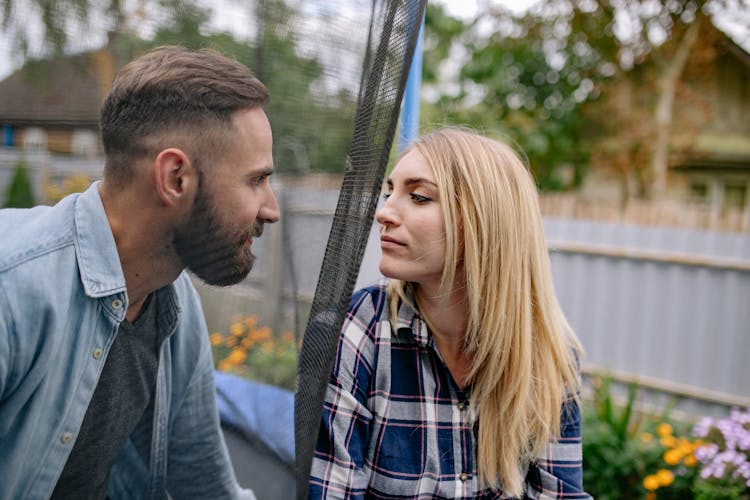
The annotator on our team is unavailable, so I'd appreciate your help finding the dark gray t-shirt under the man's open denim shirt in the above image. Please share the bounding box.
[52,293,163,500]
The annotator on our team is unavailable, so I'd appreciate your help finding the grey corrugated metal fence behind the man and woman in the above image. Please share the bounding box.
[200,185,750,415]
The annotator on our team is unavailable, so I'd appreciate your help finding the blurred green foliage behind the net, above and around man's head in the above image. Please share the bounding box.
[0,0,356,172]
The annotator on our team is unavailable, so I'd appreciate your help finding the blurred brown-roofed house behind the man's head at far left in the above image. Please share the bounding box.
[0,49,116,204]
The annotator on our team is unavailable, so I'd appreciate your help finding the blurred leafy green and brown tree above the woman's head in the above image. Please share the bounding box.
[425,0,750,198]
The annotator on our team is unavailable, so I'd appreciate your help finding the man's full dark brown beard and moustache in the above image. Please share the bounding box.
[173,186,263,286]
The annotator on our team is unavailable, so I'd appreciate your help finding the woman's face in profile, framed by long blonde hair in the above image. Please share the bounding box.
[375,150,445,286]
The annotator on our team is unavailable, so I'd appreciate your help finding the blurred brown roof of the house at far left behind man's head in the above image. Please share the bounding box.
[0,51,111,128]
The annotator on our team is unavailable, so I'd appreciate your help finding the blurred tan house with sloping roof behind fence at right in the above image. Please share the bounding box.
[581,23,750,215]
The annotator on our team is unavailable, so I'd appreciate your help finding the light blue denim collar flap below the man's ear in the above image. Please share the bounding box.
[74,181,126,298]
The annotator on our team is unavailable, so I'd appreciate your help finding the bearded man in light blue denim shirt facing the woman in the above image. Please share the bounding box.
[0,47,279,499]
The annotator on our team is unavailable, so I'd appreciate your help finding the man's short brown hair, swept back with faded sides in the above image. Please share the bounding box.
[100,46,269,186]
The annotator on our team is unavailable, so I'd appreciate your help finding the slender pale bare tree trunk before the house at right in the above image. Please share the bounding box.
[650,14,702,199]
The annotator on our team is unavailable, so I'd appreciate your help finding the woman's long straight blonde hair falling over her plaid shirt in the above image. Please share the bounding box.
[389,128,583,496]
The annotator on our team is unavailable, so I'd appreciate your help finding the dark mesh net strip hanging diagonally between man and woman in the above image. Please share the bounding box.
[295,0,425,498]
